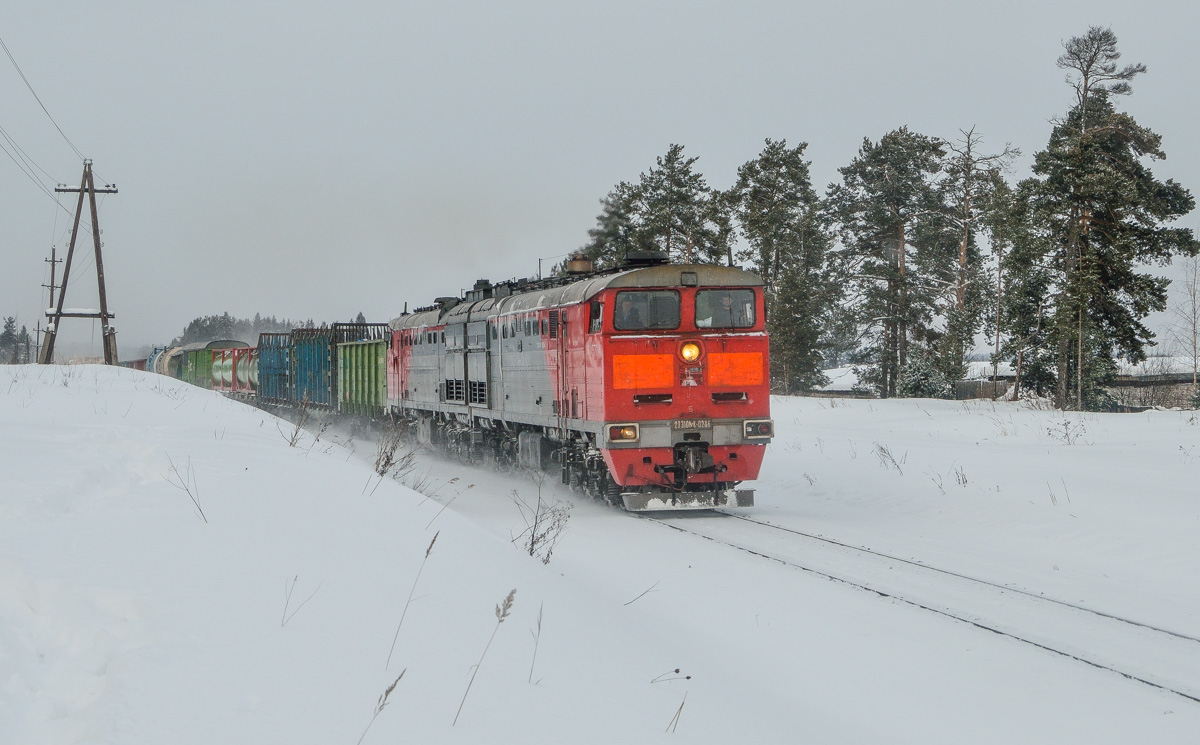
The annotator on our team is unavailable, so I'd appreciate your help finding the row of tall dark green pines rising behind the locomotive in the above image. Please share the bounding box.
[559,26,1200,410]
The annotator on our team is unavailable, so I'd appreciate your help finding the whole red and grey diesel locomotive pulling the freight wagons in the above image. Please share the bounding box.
[386,260,774,511]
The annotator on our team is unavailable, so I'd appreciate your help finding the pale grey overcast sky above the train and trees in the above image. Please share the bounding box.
[0,0,1200,356]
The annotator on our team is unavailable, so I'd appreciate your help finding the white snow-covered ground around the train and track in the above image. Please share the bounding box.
[0,366,1200,745]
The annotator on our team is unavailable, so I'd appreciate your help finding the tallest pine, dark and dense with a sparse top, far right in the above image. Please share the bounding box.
[1024,26,1200,409]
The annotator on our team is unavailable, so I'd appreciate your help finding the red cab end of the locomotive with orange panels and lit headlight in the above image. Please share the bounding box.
[589,266,774,510]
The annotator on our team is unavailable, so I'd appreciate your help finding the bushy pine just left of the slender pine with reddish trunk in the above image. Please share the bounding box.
[827,127,946,398]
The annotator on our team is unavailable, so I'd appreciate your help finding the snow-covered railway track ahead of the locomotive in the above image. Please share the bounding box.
[638,512,1200,703]
